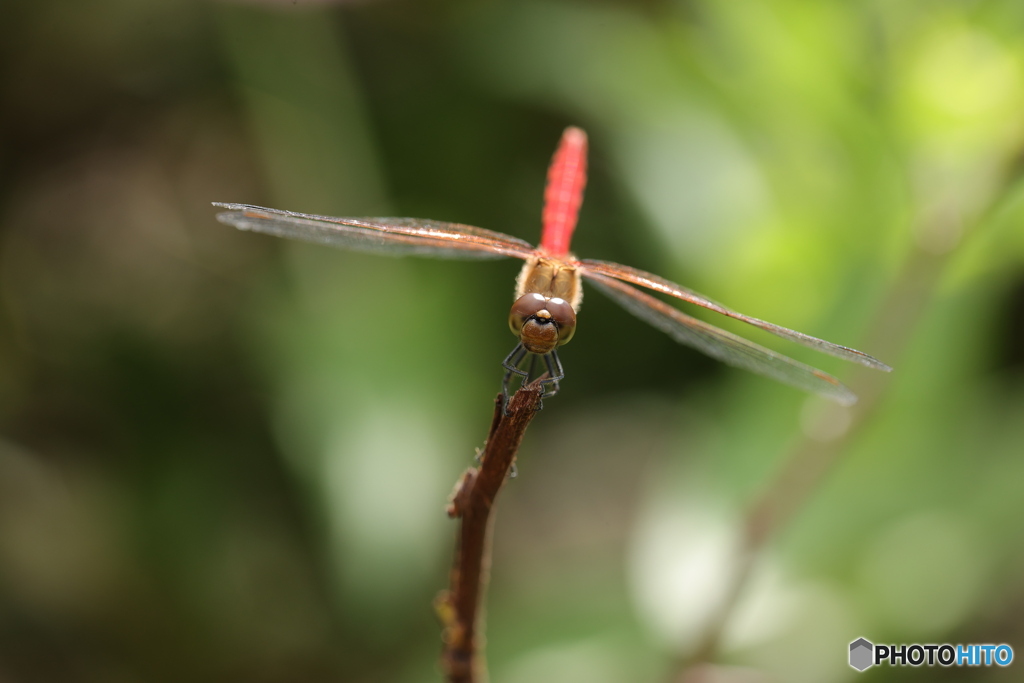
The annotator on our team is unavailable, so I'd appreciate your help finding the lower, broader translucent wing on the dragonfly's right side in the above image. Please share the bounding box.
[583,269,857,405]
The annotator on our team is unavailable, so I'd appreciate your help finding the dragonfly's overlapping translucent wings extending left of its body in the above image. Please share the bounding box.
[213,202,534,259]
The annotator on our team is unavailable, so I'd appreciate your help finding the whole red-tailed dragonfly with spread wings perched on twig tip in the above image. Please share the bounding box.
[214,126,892,405]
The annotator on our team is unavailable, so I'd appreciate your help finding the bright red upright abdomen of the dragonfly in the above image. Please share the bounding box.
[541,126,587,257]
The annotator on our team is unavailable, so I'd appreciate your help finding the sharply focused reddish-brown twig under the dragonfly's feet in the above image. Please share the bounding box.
[434,381,543,683]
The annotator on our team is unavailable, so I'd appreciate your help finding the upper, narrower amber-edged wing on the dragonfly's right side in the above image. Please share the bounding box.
[580,260,892,373]
